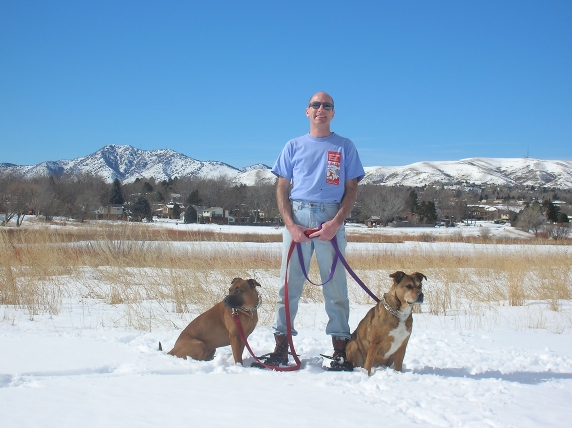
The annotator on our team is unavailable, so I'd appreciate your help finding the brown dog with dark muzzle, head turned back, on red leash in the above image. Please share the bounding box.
[169,278,260,364]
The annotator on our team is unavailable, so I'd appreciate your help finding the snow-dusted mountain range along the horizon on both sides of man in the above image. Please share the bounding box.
[0,145,572,189]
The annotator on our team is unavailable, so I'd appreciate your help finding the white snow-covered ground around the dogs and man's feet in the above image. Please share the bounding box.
[0,222,572,428]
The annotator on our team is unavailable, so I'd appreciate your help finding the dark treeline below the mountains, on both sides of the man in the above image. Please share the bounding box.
[0,175,572,229]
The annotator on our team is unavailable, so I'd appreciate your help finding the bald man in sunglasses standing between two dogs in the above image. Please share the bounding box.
[258,92,365,371]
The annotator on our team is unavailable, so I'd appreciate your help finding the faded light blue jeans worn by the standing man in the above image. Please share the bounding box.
[273,201,351,339]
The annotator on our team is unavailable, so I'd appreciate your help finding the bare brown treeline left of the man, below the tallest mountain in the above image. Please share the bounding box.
[0,175,278,226]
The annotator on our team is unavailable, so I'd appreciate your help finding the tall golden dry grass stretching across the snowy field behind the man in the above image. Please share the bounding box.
[0,223,572,330]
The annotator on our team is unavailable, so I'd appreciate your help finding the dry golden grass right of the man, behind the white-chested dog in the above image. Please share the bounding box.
[348,244,572,315]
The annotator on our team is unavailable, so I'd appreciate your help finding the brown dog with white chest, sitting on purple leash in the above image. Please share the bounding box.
[346,271,427,376]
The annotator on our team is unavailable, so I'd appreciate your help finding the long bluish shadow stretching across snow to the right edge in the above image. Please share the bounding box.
[407,366,572,385]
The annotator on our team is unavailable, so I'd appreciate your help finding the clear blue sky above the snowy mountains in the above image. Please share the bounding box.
[0,0,572,168]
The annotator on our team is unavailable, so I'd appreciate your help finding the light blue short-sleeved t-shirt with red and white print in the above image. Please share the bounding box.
[272,133,365,203]
